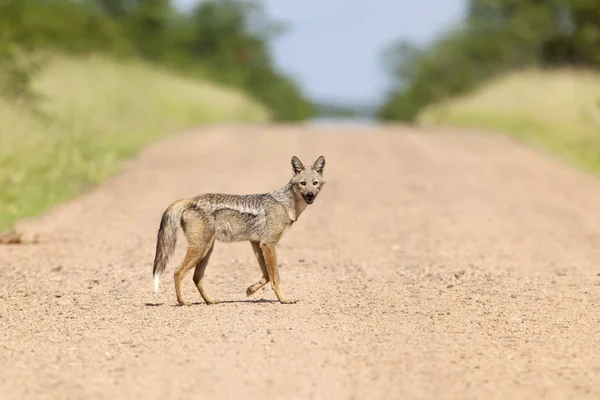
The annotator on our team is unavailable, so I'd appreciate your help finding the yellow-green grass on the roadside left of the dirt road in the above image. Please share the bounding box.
[0,56,269,231]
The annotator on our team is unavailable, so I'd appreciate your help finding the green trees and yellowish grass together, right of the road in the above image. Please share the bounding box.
[378,0,600,172]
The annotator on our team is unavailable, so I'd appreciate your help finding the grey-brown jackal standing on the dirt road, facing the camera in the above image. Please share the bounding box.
[153,156,325,305]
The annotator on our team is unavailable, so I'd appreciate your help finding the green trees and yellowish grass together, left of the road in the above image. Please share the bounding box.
[0,0,315,230]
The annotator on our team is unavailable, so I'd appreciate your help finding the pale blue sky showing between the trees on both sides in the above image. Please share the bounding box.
[175,0,465,104]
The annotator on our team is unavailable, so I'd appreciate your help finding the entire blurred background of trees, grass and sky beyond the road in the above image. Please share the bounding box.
[0,0,600,230]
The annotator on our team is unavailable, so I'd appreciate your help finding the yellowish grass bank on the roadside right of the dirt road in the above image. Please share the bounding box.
[418,70,600,173]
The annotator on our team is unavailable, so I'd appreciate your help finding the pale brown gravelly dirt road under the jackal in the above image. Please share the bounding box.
[0,126,600,400]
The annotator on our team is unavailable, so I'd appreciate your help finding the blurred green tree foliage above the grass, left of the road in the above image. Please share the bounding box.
[0,0,316,120]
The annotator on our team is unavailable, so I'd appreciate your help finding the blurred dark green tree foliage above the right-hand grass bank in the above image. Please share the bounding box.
[378,0,600,121]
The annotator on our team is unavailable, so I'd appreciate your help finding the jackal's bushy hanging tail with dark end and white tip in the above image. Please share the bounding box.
[152,199,191,294]
